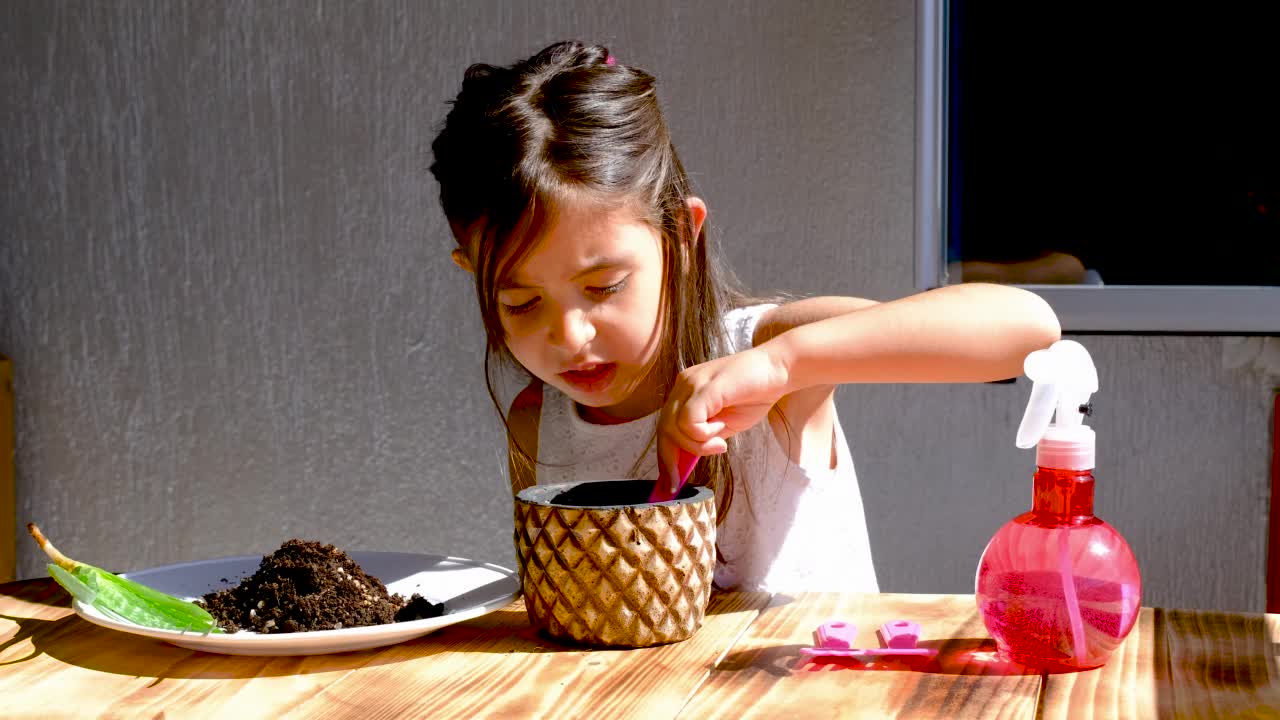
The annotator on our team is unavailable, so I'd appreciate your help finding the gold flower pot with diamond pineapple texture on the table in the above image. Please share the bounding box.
[515,480,716,647]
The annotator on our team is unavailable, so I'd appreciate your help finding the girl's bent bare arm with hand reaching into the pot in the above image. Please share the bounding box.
[658,283,1061,479]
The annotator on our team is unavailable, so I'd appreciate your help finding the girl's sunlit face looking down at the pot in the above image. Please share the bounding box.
[498,206,663,421]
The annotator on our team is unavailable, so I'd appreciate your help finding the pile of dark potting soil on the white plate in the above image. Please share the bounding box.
[201,539,444,633]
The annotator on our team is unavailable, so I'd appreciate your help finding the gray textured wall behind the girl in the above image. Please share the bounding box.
[0,0,1270,610]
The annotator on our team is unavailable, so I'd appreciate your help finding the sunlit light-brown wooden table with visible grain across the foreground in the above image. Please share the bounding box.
[0,579,1280,720]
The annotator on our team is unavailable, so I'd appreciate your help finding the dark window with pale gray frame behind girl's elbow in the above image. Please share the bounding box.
[916,0,1280,334]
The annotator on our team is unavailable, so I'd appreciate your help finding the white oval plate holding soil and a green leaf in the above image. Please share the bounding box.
[72,551,520,655]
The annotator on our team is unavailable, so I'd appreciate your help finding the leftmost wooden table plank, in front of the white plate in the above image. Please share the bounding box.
[0,579,465,720]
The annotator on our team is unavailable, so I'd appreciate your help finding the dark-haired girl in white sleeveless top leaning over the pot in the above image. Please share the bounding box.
[431,42,1060,592]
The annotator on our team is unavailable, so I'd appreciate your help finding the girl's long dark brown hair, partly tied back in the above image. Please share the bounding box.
[431,42,748,520]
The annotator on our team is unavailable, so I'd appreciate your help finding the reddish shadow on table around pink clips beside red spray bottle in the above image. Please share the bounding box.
[716,638,1039,676]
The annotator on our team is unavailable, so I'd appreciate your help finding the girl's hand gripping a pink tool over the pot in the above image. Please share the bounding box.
[658,347,788,478]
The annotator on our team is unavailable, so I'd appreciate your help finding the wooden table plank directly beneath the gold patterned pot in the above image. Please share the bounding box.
[287,593,769,719]
